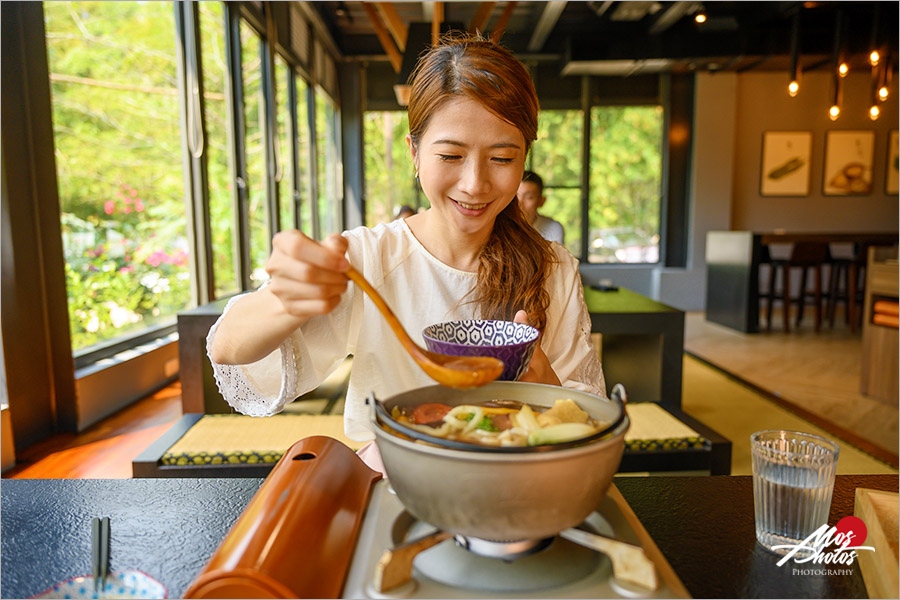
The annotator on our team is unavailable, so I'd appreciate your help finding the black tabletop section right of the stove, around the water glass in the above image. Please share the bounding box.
[616,475,898,598]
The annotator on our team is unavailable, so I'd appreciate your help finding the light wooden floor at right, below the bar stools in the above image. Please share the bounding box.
[685,313,898,467]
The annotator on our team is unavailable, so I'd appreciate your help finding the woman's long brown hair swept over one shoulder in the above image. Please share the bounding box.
[408,34,556,330]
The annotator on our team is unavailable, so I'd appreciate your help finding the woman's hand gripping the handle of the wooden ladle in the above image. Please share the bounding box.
[266,230,350,322]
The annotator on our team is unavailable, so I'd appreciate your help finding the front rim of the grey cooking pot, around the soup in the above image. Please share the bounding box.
[366,384,631,455]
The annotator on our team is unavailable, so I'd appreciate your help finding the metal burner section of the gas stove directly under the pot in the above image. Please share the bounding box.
[342,480,678,598]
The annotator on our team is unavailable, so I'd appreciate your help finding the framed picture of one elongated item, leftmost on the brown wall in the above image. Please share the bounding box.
[759,131,812,196]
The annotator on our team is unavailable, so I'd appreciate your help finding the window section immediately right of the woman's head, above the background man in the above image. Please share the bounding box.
[528,110,584,257]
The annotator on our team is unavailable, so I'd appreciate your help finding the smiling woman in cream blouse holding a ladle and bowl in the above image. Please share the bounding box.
[207,31,605,464]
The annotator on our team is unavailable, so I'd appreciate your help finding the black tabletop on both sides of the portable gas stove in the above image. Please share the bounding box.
[0,475,898,598]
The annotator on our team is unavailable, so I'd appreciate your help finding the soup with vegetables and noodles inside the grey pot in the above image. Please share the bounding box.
[391,398,609,446]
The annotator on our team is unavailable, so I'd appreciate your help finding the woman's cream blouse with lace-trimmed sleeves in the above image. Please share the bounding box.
[207,219,606,441]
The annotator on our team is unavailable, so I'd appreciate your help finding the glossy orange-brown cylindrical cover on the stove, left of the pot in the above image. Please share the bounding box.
[185,436,381,598]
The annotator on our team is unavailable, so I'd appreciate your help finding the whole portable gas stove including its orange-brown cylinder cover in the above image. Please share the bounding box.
[185,437,689,598]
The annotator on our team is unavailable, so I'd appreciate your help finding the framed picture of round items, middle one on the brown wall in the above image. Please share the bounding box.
[822,130,875,196]
